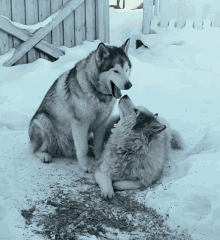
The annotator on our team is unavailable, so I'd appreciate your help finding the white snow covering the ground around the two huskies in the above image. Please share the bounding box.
[0,4,220,240]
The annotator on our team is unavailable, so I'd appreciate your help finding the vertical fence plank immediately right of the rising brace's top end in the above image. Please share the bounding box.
[86,0,95,41]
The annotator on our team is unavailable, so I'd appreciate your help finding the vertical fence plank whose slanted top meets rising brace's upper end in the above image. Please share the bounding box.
[75,2,85,45]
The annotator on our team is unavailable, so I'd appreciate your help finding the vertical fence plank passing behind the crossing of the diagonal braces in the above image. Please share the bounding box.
[25,0,39,63]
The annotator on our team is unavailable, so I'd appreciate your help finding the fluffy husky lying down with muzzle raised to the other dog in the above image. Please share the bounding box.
[94,95,184,198]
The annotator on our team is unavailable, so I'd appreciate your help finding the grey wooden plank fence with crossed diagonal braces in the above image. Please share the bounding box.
[0,0,109,66]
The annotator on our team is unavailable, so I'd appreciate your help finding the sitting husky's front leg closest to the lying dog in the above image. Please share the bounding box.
[94,118,108,159]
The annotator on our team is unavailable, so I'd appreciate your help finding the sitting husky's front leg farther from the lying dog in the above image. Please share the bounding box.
[72,122,92,172]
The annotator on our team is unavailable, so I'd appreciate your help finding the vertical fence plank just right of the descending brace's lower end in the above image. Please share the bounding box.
[63,0,75,48]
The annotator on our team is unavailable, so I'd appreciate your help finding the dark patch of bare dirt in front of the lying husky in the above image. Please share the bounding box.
[21,175,191,240]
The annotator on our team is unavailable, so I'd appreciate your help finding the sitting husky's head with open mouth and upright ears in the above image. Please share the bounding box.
[96,39,132,99]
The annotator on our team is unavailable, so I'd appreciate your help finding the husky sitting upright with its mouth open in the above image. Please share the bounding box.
[29,39,132,172]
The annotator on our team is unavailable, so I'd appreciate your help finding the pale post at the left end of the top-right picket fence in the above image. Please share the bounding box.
[142,0,153,35]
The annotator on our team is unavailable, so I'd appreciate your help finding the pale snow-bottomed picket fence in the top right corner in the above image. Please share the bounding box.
[142,0,220,34]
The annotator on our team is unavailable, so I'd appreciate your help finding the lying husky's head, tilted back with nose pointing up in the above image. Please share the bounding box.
[118,95,166,143]
